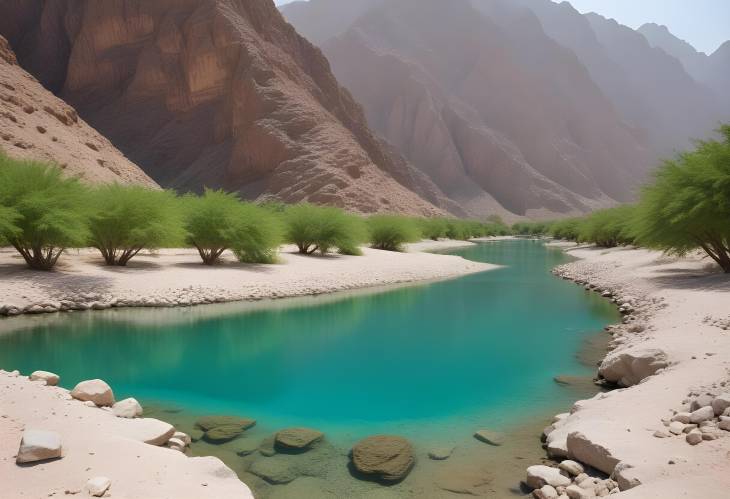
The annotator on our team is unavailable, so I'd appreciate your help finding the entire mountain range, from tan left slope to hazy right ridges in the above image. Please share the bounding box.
[0,0,730,219]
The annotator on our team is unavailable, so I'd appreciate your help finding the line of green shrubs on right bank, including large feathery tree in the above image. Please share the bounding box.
[513,125,730,273]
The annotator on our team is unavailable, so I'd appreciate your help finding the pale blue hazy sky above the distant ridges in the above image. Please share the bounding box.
[276,0,730,53]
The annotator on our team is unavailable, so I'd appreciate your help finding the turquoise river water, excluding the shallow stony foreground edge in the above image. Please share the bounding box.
[0,240,617,497]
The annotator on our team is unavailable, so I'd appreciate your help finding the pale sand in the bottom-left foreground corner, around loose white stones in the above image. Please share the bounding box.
[0,372,253,499]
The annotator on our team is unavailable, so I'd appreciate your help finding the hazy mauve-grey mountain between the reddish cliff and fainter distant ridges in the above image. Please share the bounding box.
[283,0,650,216]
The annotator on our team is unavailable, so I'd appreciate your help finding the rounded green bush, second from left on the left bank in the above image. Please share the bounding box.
[89,184,184,266]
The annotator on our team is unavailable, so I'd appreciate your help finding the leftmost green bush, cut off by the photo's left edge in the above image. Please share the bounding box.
[0,153,88,270]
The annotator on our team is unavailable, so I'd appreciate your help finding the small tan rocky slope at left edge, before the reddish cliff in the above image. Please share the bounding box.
[0,37,157,187]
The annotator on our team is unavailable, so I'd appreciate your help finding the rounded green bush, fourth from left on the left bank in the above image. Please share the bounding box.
[284,203,367,255]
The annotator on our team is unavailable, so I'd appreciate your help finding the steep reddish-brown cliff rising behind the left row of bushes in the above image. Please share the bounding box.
[0,0,450,214]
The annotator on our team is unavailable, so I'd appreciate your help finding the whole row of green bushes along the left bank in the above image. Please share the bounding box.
[0,154,509,270]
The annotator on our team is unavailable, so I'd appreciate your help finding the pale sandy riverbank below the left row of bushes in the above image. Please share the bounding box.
[0,241,495,315]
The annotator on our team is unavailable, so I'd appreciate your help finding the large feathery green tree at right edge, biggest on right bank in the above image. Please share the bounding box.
[630,125,730,273]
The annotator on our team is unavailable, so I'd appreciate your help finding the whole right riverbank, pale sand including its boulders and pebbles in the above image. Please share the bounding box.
[533,245,730,499]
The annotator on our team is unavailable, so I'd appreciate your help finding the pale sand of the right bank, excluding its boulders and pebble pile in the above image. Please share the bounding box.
[544,248,730,499]
